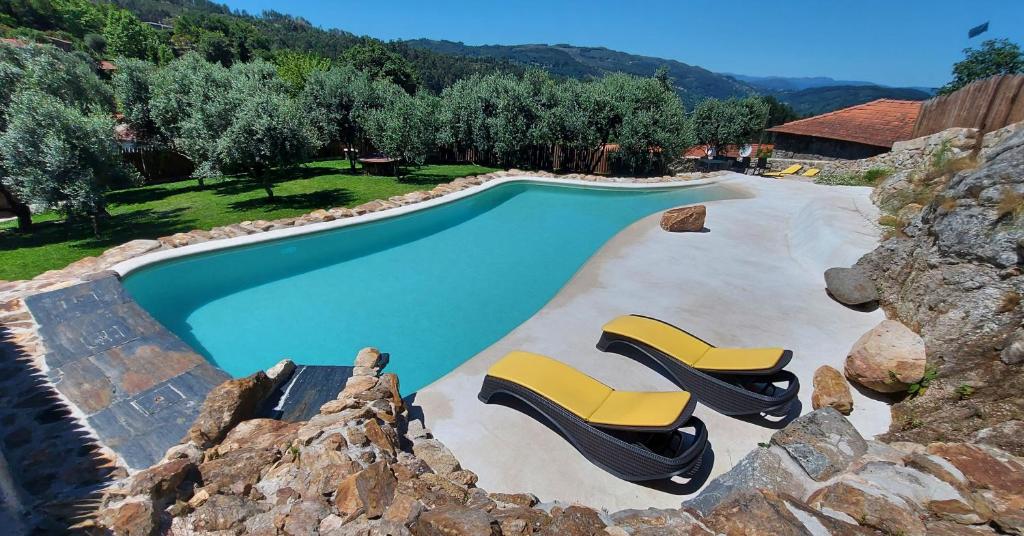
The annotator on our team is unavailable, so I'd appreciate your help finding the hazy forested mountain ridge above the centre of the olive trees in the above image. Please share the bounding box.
[403,39,758,107]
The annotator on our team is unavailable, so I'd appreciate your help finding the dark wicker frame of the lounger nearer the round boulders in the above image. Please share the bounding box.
[597,315,800,416]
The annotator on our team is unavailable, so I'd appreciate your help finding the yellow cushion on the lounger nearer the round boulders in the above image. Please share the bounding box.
[603,315,785,372]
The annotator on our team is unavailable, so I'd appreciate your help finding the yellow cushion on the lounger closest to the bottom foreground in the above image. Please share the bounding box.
[487,352,690,427]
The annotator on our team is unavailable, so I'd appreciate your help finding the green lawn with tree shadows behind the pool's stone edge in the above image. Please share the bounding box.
[0,160,494,280]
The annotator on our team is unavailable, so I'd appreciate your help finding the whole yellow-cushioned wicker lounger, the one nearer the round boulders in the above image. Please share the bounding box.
[597,315,800,415]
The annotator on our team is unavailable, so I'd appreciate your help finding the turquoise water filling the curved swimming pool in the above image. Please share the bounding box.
[124,182,735,394]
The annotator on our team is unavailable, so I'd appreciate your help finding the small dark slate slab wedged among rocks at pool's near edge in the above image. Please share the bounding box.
[261,365,352,422]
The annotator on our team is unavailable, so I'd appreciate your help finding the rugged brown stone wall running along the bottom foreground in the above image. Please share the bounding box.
[92,356,1024,536]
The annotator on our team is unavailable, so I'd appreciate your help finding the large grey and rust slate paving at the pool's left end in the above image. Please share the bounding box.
[26,275,230,468]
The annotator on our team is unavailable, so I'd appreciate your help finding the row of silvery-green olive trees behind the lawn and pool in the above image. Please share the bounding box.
[0,40,767,233]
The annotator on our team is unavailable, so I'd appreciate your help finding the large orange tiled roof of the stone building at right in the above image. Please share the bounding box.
[768,98,921,148]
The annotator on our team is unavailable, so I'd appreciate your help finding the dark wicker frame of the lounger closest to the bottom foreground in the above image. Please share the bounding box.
[477,376,708,482]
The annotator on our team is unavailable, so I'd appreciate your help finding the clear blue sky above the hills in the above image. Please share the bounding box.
[226,0,1024,86]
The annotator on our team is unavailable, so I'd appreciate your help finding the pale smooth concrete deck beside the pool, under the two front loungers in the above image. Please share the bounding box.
[414,174,890,509]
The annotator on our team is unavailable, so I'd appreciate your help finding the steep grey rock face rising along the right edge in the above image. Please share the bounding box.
[858,124,1024,454]
